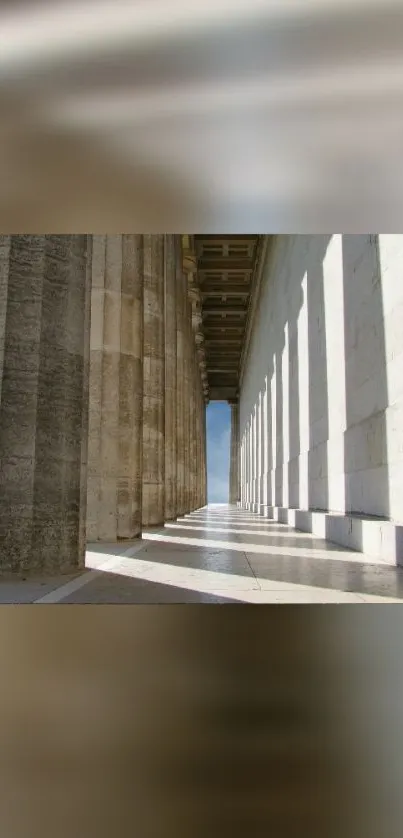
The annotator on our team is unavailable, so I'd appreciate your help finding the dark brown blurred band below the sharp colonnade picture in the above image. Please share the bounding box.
[0,605,403,838]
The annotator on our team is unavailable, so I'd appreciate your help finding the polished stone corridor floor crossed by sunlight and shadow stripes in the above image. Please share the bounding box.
[0,504,403,604]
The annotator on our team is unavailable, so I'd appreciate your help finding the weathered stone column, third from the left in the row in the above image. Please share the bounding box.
[142,235,165,526]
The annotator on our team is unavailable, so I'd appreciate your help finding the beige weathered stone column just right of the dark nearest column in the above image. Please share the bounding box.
[87,235,143,541]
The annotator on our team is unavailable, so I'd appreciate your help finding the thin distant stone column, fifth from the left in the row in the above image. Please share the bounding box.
[175,241,187,516]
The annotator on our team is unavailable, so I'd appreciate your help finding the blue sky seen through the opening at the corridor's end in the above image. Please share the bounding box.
[206,402,231,503]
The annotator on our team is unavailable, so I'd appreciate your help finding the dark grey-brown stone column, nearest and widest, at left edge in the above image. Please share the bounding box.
[0,235,90,573]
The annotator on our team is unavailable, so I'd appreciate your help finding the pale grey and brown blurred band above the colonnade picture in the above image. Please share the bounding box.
[0,0,403,233]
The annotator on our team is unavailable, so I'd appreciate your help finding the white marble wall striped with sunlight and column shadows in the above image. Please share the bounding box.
[240,234,403,522]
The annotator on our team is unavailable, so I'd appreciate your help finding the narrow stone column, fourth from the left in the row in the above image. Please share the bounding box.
[165,235,177,521]
